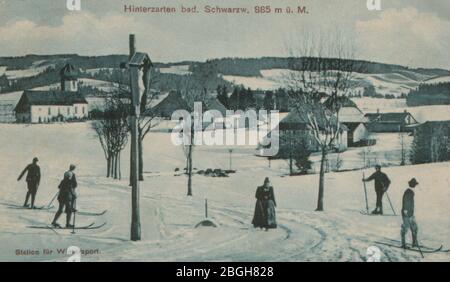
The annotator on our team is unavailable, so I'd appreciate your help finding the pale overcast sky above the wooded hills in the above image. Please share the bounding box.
[0,0,450,69]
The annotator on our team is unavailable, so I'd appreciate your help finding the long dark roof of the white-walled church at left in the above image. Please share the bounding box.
[16,90,88,112]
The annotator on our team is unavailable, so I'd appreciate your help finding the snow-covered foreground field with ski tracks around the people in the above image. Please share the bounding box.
[0,123,450,261]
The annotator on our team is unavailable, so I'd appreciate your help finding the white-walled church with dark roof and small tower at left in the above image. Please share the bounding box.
[14,64,89,123]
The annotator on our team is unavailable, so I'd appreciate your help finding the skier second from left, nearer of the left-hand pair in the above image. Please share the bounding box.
[52,165,77,228]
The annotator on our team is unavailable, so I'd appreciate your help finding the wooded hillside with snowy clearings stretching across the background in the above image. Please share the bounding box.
[0,54,450,97]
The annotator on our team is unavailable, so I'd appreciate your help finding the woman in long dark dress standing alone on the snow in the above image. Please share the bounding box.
[252,177,277,231]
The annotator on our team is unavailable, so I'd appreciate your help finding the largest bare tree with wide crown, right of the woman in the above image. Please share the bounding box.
[286,32,362,211]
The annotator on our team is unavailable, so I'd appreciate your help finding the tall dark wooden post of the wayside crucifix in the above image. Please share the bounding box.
[130,34,141,241]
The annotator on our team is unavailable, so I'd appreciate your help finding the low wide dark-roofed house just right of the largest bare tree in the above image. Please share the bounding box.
[365,110,419,133]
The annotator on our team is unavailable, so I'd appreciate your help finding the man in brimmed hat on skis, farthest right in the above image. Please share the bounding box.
[400,178,419,248]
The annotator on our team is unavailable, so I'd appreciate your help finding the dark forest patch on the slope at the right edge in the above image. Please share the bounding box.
[406,82,450,106]
